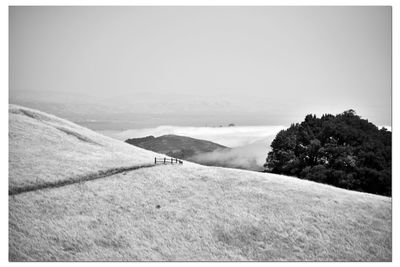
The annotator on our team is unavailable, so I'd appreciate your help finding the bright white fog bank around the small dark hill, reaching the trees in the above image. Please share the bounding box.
[110,126,286,171]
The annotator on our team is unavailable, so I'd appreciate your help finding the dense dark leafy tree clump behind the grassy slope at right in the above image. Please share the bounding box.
[264,110,392,196]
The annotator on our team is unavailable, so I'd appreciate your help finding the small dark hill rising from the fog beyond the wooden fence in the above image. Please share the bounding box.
[125,134,229,159]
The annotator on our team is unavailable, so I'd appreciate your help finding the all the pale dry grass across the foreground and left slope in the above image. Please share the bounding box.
[9,106,392,261]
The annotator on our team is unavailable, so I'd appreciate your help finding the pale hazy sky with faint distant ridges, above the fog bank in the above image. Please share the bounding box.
[9,7,391,130]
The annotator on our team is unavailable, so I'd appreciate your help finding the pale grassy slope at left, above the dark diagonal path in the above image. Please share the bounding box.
[9,105,163,195]
